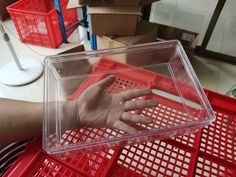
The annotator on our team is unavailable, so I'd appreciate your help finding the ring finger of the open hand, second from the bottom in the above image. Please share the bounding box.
[121,112,152,124]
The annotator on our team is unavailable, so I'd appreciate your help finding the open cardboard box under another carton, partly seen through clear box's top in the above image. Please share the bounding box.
[97,21,158,66]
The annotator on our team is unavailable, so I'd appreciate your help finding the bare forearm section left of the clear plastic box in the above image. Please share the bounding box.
[0,98,43,145]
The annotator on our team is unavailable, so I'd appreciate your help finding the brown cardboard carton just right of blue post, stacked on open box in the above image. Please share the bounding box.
[88,7,141,36]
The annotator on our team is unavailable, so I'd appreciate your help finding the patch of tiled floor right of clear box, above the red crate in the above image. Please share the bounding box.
[191,56,236,94]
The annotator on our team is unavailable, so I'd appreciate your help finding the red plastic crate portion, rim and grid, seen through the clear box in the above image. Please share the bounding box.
[48,58,208,156]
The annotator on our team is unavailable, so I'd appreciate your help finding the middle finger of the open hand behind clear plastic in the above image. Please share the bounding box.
[124,100,158,111]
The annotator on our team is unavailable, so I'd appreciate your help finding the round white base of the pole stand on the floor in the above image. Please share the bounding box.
[0,58,43,86]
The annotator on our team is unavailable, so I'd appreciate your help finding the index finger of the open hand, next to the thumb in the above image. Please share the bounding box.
[121,88,152,101]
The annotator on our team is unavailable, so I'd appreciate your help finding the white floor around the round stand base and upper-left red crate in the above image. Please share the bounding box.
[0,20,89,102]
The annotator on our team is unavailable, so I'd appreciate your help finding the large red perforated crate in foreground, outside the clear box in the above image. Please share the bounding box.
[5,59,236,177]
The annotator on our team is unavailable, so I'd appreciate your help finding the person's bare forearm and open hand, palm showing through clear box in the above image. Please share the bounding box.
[0,76,158,144]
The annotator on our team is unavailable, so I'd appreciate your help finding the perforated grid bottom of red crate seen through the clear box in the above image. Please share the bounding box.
[58,75,197,149]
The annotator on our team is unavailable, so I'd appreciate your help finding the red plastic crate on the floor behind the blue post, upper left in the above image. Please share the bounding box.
[7,0,77,48]
